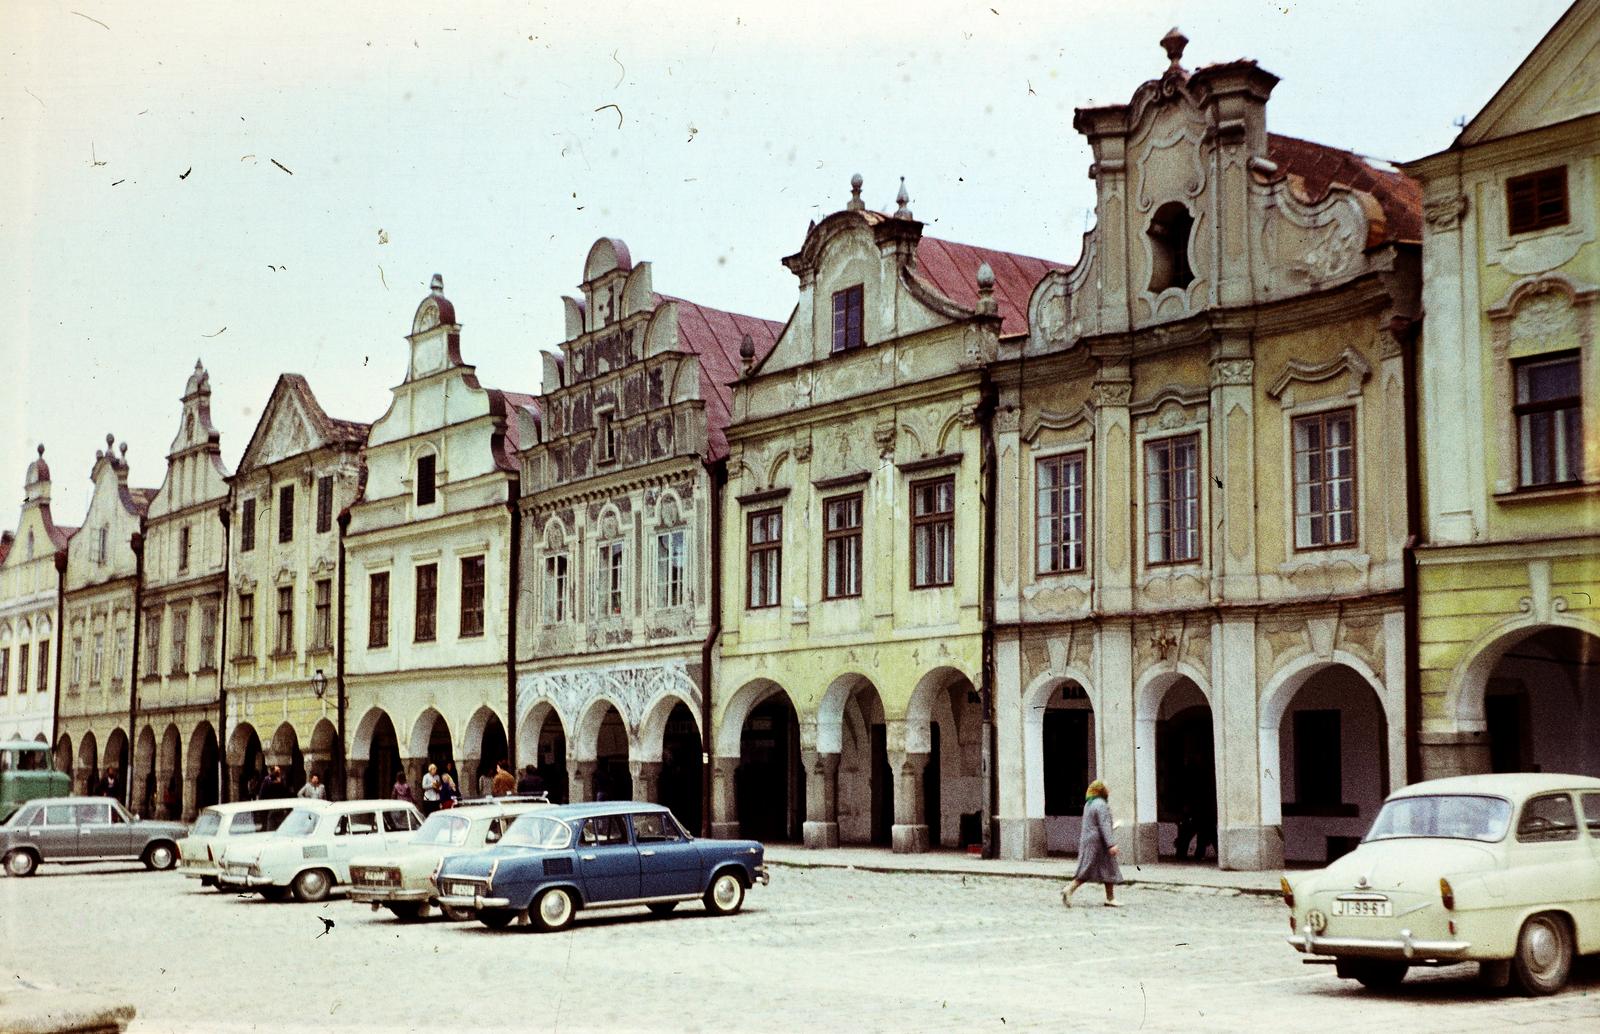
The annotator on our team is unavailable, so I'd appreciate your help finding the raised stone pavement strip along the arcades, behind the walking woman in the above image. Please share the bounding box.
[766,844,1283,896]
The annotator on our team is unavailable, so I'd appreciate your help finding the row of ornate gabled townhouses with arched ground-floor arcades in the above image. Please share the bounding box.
[0,20,1600,869]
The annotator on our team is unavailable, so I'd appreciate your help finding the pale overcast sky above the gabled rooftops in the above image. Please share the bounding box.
[0,0,1568,527]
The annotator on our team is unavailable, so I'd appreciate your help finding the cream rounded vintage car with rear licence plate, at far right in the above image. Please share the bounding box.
[1283,773,1600,994]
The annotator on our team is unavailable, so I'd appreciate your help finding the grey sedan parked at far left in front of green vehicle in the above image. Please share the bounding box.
[0,797,189,876]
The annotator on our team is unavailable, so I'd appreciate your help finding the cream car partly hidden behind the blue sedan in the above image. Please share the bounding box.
[350,797,549,922]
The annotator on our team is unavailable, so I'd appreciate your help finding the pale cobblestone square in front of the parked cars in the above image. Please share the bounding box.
[0,866,1600,1034]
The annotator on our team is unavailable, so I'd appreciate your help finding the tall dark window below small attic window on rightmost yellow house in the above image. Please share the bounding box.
[1514,352,1584,488]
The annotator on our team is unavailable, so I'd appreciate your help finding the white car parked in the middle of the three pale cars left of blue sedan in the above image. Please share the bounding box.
[216,800,422,901]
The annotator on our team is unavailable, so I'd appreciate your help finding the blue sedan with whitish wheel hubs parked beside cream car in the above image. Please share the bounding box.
[434,800,768,930]
